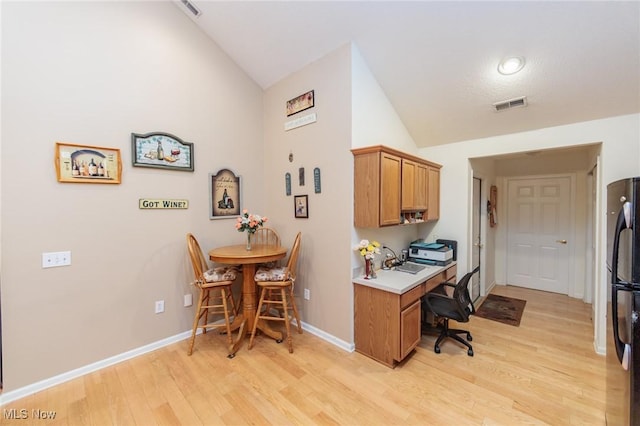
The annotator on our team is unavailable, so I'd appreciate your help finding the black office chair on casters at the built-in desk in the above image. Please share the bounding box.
[422,266,480,356]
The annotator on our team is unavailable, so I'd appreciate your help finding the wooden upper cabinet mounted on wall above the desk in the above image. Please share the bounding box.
[352,145,441,228]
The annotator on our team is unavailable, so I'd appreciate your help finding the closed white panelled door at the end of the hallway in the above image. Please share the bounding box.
[507,177,572,294]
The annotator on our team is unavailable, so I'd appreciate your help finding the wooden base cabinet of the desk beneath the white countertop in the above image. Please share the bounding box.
[353,264,456,368]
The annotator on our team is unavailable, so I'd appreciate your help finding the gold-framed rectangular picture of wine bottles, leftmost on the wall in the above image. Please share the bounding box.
[55,142,122,183]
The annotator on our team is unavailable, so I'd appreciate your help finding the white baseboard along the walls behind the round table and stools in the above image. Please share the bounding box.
[0,321,355,406]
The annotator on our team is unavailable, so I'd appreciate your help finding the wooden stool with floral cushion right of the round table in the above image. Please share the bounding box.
[249,232,302,353]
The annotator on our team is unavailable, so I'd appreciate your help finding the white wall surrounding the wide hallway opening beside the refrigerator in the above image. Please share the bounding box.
[420,114,640,353]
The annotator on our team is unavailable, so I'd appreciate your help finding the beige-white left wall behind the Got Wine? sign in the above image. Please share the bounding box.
[0,2,266,393]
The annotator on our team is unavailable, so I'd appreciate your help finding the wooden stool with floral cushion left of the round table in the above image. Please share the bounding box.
[187,234,244,358]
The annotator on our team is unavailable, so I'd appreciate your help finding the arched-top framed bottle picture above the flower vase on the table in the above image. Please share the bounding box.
[209,169,242,219]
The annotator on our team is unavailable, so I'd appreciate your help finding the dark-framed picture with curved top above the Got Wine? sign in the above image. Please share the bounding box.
[131,132,193,172]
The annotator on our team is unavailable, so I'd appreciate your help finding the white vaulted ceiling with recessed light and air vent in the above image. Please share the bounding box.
[175,0,640,147]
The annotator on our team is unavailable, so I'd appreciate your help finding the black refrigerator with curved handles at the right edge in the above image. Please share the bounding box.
[606,177,640,425]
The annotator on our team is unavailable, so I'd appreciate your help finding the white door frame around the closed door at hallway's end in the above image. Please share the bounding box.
[498,173,584,298]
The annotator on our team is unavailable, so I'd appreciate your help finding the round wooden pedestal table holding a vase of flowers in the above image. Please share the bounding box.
[209,244,287,346]
